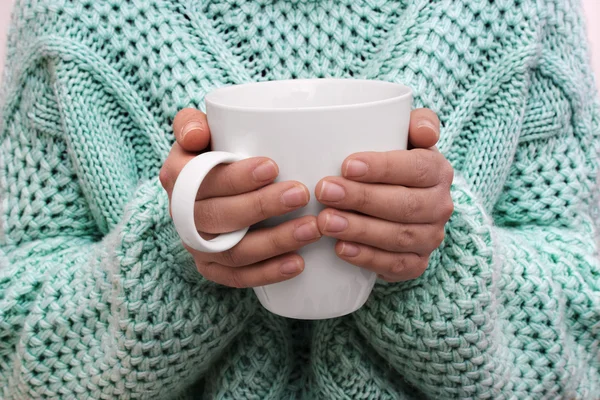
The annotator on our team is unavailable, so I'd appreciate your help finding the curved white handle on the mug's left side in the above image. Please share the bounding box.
[171,151,249,253]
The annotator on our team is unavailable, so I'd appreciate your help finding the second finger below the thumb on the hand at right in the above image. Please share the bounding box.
[315,177,454,224]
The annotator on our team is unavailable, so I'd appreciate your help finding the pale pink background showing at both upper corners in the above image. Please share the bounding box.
[0,0,600,88]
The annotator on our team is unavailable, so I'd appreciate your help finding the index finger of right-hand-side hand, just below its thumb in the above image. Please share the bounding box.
[342,149,453,188]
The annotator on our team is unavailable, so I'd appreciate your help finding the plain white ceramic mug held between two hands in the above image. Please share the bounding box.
[171,79,412,319]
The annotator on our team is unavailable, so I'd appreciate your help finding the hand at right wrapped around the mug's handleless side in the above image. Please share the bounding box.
[315,109,454,282]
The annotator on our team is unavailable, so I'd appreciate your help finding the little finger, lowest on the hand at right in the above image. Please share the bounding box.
[335,241,429,282]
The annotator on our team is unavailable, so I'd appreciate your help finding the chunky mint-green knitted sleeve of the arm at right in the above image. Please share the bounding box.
[354,2,600,399]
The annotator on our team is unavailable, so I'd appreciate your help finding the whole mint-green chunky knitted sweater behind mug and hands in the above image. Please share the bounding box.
[0,0,600,400]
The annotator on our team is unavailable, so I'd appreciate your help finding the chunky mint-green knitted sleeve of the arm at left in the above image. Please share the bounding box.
[0,34,257,400]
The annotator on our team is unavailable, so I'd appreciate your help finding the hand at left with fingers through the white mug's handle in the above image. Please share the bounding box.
[160,108,321,288]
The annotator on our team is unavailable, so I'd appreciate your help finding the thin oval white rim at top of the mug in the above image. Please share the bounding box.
[204,78,413,113]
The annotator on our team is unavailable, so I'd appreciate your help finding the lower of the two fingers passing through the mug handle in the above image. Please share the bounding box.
[194,181,310,233]
